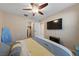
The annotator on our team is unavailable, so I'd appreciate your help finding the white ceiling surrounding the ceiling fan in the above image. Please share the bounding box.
[0,3,74,20]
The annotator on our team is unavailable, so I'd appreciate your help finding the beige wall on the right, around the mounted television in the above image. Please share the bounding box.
[43,4,79,49]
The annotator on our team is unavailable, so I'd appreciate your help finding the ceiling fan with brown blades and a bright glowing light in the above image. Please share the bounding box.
[23,3,48,16]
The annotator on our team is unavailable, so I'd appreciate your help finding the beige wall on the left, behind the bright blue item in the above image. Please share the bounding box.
[0,11,33,41]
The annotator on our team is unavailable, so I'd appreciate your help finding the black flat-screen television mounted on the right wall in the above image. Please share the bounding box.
[47,18,62,30]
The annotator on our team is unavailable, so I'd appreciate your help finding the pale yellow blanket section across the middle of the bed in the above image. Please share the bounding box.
[27,38,54,56]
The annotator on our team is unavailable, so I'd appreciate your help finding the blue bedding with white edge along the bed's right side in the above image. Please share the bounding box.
[34,35,73,56]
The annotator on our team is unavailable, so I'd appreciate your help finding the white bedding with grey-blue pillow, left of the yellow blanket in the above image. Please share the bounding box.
[10,39,30,56]
